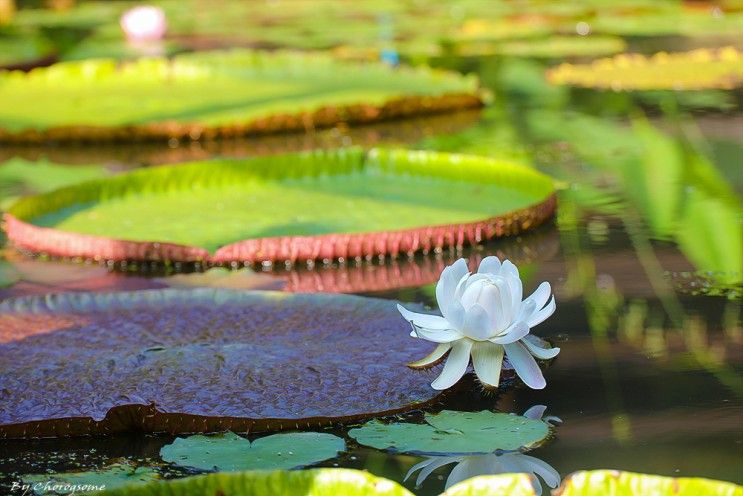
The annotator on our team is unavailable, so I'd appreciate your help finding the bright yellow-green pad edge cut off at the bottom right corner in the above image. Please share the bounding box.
[557,470,743,496]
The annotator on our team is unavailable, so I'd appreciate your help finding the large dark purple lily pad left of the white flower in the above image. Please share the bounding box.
[0,289,438,438]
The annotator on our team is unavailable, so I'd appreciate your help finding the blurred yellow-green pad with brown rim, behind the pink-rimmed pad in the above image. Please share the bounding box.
[0,50,481,142]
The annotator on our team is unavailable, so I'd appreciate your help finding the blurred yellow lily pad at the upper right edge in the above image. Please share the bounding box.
[547,47,743,90]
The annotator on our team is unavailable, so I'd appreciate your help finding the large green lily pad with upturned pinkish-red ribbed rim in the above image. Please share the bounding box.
[5,149,555,263]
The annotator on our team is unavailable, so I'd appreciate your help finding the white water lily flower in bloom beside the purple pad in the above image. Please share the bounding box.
[397,256,560,390]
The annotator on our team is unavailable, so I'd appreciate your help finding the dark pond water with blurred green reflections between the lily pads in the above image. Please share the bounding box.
[0,30,743,494]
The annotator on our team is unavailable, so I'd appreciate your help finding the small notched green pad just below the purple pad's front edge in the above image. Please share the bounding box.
[160,432,346,472]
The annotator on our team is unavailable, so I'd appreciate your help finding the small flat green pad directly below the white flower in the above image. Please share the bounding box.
[348,410,550,454]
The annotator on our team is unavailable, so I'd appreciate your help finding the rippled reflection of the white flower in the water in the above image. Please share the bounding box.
[405,451,560,494]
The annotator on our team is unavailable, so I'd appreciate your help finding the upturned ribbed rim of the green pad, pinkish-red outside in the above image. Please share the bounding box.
[3,149,557,265]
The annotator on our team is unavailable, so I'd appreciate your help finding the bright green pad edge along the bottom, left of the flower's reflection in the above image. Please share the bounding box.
[99,468,413,496]
